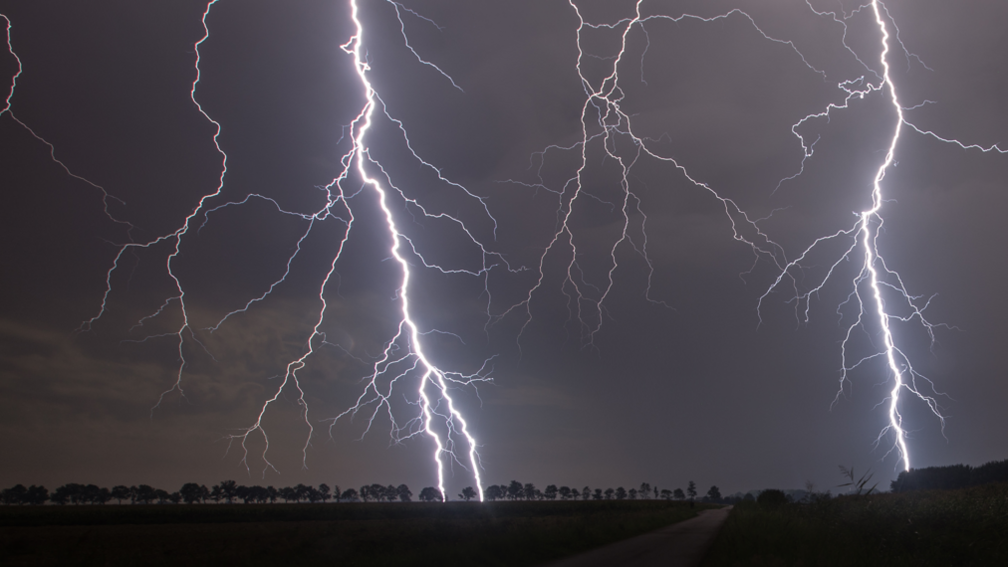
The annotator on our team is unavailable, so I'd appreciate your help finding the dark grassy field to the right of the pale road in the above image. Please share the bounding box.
[704,483,1008,567]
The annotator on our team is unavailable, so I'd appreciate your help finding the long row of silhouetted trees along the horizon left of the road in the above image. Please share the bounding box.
[0,480,724,505]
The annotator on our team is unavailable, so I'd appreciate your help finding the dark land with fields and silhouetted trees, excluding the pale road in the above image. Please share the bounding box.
[0,460,1008,567]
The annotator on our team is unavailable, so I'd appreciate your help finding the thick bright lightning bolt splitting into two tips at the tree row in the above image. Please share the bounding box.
[182,0,496,497]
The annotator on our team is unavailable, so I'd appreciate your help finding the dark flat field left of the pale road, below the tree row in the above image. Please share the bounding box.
[0,500,704,567]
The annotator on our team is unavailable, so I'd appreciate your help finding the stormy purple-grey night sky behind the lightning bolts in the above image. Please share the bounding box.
[0,0,1008,495]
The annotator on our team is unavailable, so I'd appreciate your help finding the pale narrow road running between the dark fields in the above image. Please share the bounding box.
[546,506,732,567]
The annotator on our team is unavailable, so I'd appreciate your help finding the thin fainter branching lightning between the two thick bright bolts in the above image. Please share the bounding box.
[498,0,802,346]
